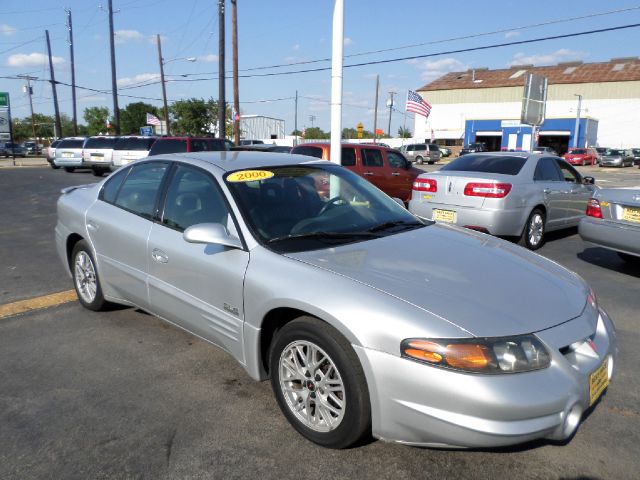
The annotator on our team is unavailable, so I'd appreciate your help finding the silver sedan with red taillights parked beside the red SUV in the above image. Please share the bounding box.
[409,152,594,250]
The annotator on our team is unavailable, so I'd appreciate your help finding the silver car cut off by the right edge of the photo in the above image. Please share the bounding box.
[578,188,640,265]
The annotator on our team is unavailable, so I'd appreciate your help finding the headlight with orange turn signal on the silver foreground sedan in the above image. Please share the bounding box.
[400,335,551,374]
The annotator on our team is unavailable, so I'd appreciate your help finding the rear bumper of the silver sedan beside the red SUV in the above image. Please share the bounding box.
[409,198,527,236]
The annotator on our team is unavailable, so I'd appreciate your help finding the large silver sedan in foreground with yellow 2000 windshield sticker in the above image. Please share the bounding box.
[56,152,617,448]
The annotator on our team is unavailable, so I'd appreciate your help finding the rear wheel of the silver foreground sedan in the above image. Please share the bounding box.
[71,240,109,312]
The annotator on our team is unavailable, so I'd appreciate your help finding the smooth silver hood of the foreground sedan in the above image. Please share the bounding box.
[286,224,588,337]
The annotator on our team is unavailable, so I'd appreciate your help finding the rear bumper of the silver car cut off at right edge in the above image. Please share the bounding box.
[578,217,640,255]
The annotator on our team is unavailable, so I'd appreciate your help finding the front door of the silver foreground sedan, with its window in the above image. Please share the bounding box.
[146,164,249,361]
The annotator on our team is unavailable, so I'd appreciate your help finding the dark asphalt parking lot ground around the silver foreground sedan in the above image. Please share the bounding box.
[0,165,640,479]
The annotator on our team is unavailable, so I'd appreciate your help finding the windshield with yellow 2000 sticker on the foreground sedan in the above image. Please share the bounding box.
[225,162,426,253]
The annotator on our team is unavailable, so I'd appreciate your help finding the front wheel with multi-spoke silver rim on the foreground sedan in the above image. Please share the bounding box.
[269,316,371,448]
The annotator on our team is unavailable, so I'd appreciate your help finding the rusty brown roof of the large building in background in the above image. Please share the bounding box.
[418,57,640,92]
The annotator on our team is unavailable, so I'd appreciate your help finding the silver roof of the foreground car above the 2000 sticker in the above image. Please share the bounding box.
[156,150,320,172]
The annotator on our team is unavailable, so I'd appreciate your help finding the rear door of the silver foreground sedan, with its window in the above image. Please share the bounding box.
[86,162,168,309]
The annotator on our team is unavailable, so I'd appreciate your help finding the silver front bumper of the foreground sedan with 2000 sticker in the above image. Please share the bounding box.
[354,311,617,448]
